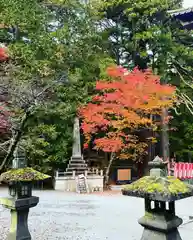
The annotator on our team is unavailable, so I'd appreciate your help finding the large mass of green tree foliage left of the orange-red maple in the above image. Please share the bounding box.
[0,0,111,172]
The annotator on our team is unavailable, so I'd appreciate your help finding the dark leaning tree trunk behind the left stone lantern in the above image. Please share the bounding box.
[0,113,30,171]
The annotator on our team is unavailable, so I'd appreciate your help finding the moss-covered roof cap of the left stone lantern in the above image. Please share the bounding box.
[0,167,51,182]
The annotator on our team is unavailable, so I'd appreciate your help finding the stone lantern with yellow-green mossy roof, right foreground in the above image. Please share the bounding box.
[122,157,193,240]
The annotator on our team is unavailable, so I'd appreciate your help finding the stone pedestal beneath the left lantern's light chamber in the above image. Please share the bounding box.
[0,197,39,240]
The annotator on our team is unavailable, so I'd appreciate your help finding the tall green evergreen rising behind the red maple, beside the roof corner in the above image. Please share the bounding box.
[98,0,193,162]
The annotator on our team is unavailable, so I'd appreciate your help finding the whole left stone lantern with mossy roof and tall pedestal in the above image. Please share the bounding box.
[0,146,50,240]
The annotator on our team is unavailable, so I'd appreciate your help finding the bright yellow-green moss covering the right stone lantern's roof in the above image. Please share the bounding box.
[123,176,192,195]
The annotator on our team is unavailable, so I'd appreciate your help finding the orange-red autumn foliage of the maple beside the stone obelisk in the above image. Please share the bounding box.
[79,67,175,159]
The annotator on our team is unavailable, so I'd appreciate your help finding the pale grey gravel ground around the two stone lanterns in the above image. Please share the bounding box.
[0,189,193,240]
